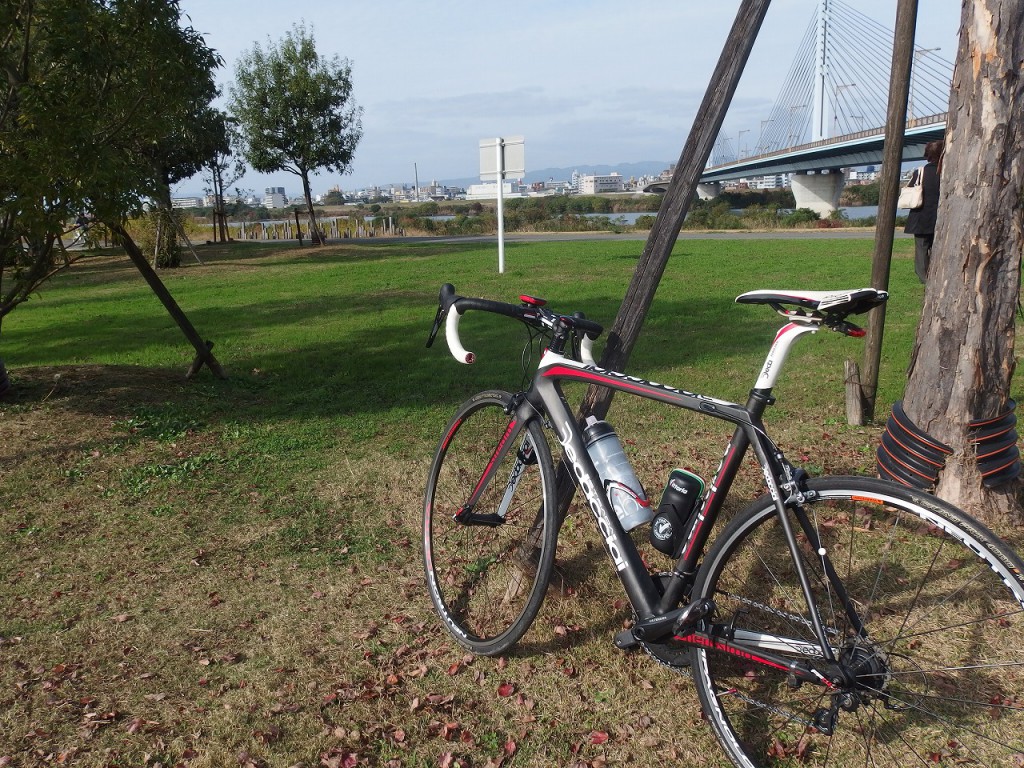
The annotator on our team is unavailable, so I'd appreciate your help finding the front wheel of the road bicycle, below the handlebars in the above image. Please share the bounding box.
[423,390,558,655]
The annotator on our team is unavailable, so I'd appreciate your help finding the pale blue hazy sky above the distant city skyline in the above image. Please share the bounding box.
[175,0,961,196]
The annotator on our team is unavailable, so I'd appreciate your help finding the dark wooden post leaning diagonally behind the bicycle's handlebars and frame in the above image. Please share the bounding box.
[558,0,771,520]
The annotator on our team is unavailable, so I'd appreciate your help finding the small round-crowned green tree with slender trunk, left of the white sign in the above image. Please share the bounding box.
[228,25,362,244]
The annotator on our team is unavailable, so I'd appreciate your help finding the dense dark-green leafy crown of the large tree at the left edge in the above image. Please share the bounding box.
[0,0,220,382]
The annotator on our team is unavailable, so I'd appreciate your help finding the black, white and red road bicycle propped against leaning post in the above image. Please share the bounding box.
[423,285,1024,768]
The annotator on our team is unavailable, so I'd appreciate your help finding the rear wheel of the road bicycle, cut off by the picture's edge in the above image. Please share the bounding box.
[694,477,1024,768]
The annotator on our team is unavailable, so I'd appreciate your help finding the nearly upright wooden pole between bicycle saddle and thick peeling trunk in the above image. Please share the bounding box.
[847,0,918,424]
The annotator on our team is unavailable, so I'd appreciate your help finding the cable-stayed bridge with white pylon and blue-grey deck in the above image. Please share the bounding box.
[699,0,953,214]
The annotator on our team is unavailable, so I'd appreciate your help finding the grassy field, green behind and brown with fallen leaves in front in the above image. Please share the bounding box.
[0,240,999,767]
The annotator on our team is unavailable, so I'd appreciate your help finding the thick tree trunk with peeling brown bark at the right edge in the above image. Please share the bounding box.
[904,0,1024,527]
